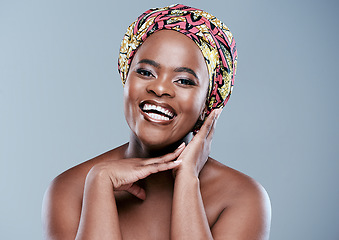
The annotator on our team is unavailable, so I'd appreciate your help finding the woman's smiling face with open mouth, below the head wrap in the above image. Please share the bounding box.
[124,30,209,148]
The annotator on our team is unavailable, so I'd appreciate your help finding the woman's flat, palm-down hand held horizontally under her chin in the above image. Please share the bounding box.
[89,144,185,200]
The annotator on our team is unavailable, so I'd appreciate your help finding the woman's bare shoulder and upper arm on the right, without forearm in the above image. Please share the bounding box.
[200,158,271,239]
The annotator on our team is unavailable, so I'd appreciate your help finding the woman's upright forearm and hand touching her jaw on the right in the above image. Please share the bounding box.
[171,109,221,239]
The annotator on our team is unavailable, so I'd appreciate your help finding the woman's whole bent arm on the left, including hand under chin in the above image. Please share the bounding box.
[43,147,183,240]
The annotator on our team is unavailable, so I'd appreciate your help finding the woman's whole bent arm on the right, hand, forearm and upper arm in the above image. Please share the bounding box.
[171,109,270,240]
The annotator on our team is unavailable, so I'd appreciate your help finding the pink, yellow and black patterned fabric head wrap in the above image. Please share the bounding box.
[118,4,237,125]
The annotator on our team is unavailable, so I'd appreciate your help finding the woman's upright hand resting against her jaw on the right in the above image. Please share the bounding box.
[173,109,222,177]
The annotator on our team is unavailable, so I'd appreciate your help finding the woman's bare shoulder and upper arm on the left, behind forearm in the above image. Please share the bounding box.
[42,145,125,239]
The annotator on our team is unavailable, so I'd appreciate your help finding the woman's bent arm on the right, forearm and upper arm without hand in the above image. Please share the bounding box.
[171,170,271,240]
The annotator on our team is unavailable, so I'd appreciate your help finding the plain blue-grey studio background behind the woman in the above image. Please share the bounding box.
[0,0,339,240]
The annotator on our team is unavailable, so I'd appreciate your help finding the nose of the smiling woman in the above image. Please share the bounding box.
[146,78,175,97]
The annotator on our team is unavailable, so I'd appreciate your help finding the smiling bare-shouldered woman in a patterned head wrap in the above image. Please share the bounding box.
[43,5,270,240]
